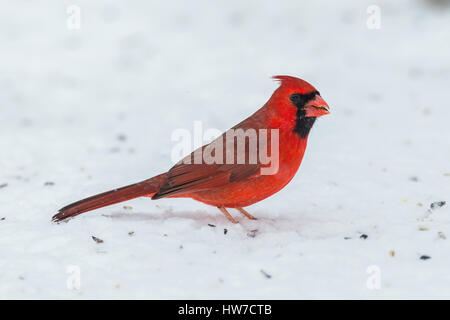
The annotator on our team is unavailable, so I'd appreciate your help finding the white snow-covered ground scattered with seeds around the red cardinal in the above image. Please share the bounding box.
[0,0,450,299]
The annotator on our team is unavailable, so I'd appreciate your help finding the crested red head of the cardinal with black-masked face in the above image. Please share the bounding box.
[273,76,330,118]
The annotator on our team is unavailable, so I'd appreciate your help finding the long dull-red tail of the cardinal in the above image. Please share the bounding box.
[52,174,167,222]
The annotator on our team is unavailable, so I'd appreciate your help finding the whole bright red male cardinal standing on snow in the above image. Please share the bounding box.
[53,76,329,223]
